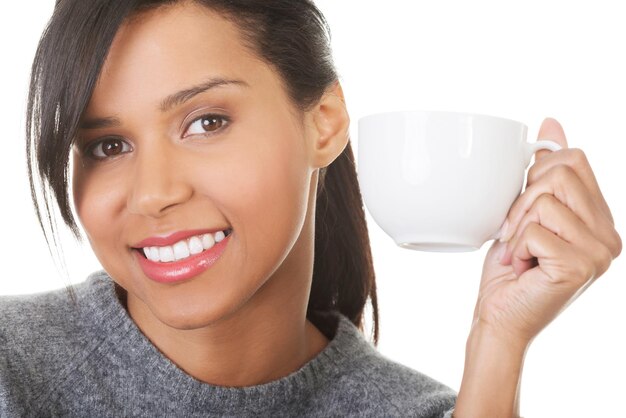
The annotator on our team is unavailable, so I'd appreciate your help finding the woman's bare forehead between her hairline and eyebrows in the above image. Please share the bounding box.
[88,2,276,113]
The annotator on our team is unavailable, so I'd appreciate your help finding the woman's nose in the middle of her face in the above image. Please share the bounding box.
[127,141,193,218]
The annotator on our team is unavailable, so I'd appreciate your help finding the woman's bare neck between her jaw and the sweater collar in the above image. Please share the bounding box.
[135,298,327,387]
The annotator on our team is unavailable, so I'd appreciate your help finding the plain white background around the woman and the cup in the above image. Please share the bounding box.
[0,0,626,417]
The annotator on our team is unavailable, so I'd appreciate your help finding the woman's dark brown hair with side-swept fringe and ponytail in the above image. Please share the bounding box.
[26,0,378,341]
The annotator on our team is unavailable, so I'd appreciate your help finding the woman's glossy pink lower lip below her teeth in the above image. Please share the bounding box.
[134,234,232,283]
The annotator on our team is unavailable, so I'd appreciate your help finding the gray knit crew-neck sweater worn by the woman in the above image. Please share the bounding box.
[0,272,455,418]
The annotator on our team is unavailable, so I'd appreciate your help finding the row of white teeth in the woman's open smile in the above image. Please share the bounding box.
[133,228,233,263]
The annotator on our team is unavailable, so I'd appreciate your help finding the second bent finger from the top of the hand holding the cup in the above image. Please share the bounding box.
[500,165,621,257]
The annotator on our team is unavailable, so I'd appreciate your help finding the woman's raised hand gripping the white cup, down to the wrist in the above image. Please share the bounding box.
[474,119,622,344]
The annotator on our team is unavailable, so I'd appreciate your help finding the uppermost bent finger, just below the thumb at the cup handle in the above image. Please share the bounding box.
[526,148,614,224]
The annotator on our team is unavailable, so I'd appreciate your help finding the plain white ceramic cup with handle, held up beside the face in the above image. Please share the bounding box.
[358,111,561,252]
